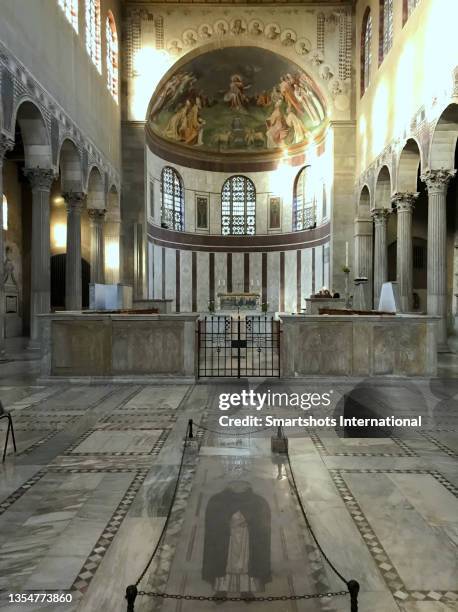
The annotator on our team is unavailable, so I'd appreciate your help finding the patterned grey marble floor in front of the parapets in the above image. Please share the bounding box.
[0,347,458,612]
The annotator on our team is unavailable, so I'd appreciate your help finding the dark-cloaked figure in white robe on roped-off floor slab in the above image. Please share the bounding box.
[202,481,272,597]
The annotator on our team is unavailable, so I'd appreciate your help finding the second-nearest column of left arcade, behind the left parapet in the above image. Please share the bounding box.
[63,191,86,310]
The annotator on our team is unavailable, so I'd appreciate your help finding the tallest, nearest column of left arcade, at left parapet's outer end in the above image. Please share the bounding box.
[24,168,56,348]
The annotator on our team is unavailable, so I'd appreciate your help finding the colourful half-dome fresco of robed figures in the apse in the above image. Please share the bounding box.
[149,47,325,152]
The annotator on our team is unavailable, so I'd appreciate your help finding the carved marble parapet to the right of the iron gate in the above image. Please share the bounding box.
[281,314,438,378]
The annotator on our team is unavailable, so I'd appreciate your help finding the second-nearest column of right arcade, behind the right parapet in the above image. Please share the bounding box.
[393,192,418,312]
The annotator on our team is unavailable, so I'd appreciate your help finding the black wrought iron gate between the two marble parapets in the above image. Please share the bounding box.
[197,315,280,378]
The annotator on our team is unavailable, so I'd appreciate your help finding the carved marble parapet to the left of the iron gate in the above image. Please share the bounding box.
[41,312,198,378]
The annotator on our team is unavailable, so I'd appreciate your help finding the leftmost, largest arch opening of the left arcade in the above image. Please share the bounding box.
[13,99,52,168]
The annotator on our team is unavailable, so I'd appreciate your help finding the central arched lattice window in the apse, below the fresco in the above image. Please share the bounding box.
[221,176,256,236]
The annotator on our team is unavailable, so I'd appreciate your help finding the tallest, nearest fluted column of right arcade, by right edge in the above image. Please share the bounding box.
[421,168,456,350]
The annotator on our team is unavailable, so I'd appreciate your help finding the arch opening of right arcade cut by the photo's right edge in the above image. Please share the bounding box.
[429,103,458,170]
